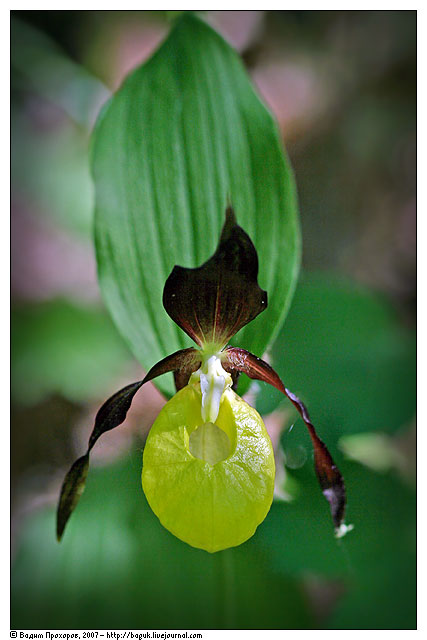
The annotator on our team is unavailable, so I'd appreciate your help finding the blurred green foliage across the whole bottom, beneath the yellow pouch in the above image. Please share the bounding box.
[12,452,415,629]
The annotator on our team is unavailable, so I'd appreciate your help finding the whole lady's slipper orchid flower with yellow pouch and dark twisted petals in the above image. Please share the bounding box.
[57,207,349,552]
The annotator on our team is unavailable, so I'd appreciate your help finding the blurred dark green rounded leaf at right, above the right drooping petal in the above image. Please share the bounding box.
[257,276,415,444]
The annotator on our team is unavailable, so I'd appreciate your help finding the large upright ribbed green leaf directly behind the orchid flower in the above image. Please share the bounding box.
[92,15,300,394]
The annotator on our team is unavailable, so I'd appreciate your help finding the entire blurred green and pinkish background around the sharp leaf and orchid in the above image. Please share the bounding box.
[11,11,416,629]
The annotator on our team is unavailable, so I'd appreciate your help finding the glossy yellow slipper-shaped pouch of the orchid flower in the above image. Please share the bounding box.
[142,385,275,552]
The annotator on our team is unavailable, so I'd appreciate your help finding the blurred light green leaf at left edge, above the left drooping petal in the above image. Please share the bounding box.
[11,300,131,405]
